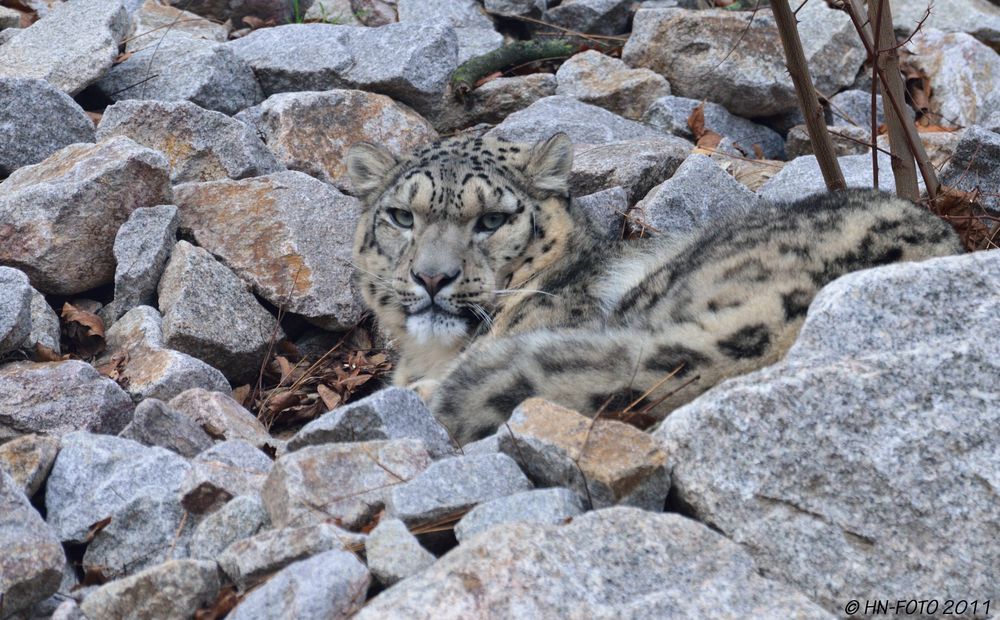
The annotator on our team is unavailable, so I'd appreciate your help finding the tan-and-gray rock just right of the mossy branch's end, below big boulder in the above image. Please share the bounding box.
[556,50,670,121]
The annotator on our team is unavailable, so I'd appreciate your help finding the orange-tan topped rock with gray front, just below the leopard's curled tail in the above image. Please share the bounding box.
[500,398,670,512]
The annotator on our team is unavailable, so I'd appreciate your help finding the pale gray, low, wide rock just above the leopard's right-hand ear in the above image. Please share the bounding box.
[486,95,666,144]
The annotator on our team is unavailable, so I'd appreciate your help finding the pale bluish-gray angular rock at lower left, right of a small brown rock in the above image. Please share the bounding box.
[45,431,191,542]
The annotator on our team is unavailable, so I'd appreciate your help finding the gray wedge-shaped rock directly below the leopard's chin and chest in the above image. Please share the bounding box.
[288,387,455,459]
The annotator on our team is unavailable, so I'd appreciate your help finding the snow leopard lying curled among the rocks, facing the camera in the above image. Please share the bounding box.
[347,133,961,444]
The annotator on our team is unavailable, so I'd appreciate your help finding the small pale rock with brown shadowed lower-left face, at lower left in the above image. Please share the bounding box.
[180,439,274,514]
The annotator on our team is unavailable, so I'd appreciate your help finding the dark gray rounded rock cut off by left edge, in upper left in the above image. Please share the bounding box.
[0,77,94,177]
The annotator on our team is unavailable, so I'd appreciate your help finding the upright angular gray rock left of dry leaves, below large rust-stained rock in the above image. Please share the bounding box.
[158,241,283,383]
